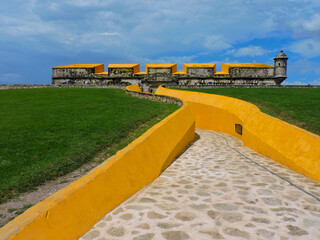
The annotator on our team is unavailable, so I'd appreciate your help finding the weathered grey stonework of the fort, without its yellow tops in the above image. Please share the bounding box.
[52,53,287,89]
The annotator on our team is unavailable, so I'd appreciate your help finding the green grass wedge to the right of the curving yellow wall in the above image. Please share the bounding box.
[175,88,320,135]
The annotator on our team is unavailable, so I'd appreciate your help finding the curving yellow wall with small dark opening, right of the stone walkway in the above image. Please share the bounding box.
[156,87,320,181]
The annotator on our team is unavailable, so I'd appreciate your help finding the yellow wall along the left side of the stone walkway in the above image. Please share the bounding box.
[0,87,195,240]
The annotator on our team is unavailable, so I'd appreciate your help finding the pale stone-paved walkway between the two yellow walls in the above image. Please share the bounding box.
[81,130,320,240]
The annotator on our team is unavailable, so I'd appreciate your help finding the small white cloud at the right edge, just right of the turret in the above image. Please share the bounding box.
[289,39,320,58]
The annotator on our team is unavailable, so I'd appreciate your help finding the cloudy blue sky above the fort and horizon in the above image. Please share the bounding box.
[0,0,320,85]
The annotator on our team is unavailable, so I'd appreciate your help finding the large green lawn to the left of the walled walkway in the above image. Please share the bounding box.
[0,88,178,202]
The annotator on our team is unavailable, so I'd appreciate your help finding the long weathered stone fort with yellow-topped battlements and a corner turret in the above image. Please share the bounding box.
[52,51,288,92]
